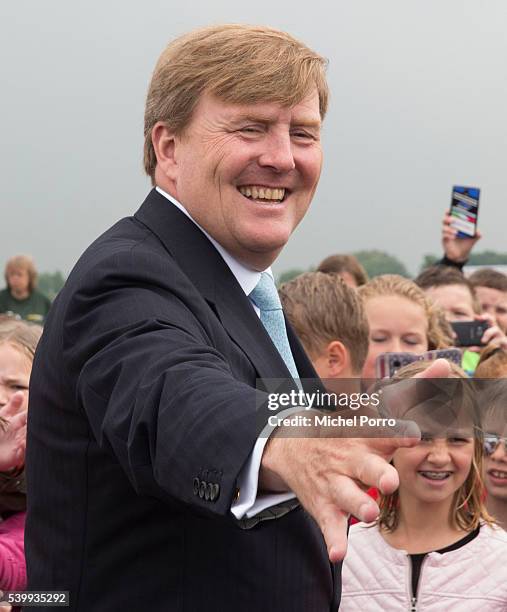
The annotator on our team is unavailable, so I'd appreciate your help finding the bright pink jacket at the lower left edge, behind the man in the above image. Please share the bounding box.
[0,512,26,591]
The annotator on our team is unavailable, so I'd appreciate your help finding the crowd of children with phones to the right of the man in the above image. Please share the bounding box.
[280,218,507,612]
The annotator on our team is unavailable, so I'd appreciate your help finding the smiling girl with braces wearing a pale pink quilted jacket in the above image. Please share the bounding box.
[340,362,507,612]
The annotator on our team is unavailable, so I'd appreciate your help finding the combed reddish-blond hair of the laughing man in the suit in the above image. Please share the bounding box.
[144,24,329,182]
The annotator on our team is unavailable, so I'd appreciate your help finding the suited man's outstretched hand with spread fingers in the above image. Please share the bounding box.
[260,359,450,562]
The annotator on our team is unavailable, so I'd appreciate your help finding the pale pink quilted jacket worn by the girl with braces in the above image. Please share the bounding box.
[340,523,507,612]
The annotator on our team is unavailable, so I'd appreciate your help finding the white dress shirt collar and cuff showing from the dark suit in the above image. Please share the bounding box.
[156,187,297,519]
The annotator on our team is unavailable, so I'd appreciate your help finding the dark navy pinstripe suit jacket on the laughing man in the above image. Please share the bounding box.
[26,191,339,612]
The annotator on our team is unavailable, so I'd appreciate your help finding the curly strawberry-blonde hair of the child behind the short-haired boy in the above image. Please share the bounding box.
[357,274,453,351]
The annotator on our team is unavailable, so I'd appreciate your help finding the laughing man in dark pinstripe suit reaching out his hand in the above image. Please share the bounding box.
[26,26,424,612]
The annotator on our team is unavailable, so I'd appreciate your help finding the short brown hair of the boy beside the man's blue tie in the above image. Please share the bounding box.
[279,272,369,373]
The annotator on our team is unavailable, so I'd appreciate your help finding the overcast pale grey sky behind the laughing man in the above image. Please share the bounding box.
[0,0,507,273]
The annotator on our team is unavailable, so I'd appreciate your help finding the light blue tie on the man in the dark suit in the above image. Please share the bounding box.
[249,272,299,379]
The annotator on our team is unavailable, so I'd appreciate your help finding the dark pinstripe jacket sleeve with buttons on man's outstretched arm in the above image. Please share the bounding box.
[63,248,259,514]
